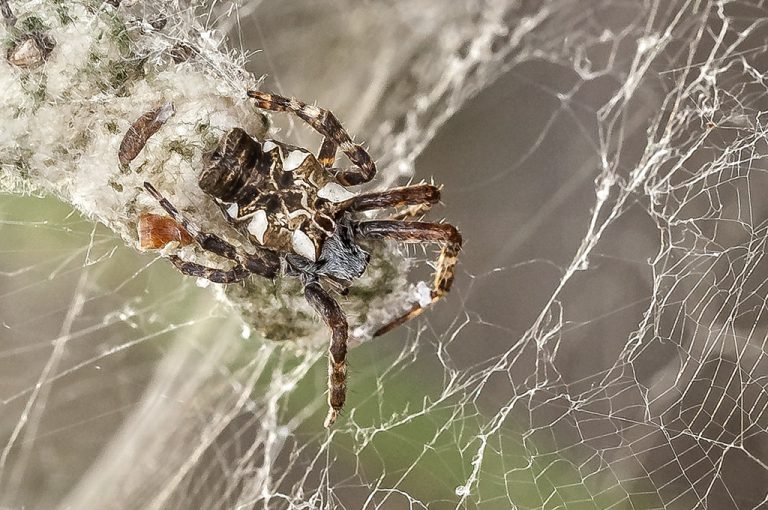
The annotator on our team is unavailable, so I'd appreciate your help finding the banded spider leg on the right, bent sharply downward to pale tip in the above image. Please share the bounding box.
[355,220,462,337]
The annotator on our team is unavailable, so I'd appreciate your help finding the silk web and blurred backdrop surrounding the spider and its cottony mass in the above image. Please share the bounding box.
[0,0,768,509]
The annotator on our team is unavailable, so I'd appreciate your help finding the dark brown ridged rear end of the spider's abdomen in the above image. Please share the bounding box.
[198,128,263,202]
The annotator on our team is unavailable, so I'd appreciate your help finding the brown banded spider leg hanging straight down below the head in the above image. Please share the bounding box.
[304,282,349,428]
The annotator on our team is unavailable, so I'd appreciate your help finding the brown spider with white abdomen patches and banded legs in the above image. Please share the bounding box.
[144,91,462,427]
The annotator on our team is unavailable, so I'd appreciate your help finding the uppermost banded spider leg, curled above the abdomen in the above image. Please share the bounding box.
[248,90,376,186]
